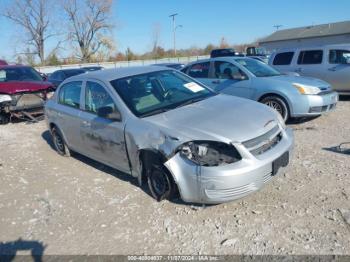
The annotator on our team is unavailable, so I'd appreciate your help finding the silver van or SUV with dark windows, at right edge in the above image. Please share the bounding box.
[269,45,350,95]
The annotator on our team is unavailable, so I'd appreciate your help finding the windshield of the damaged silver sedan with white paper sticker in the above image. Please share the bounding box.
[111,70,215,117]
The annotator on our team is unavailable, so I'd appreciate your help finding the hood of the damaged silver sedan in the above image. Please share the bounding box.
[144,94,278,143]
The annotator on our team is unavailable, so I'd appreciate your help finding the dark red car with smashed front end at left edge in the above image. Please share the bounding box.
[0,65,54,124]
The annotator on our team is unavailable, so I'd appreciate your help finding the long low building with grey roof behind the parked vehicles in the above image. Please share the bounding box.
[259,21,350,51]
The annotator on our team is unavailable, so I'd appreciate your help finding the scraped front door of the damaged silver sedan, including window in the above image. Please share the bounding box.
[80,80,130,172]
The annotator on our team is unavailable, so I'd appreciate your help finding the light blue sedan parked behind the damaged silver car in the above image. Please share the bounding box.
[182,57,338,121]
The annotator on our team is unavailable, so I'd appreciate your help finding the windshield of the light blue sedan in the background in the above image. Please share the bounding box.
[235,59,281,77]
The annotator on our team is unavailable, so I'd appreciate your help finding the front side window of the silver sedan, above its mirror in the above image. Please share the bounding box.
[85,81,118,114]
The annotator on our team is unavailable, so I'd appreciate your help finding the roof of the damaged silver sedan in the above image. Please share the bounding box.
[69,66,172,81]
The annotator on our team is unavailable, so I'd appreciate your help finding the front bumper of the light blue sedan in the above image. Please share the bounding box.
[292,91,339,117]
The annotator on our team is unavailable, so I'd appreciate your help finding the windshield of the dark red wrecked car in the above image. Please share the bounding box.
[0,67,43,82]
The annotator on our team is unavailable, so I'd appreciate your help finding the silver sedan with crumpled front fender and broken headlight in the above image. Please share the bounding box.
[45,66,293,203]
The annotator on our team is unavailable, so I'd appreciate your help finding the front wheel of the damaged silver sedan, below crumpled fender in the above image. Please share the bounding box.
[147,165,176,201]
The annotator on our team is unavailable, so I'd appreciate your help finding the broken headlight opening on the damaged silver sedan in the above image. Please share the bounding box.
[177,141,242,166]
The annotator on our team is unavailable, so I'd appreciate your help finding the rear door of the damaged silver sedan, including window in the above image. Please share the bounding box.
[53,81,83,151]
